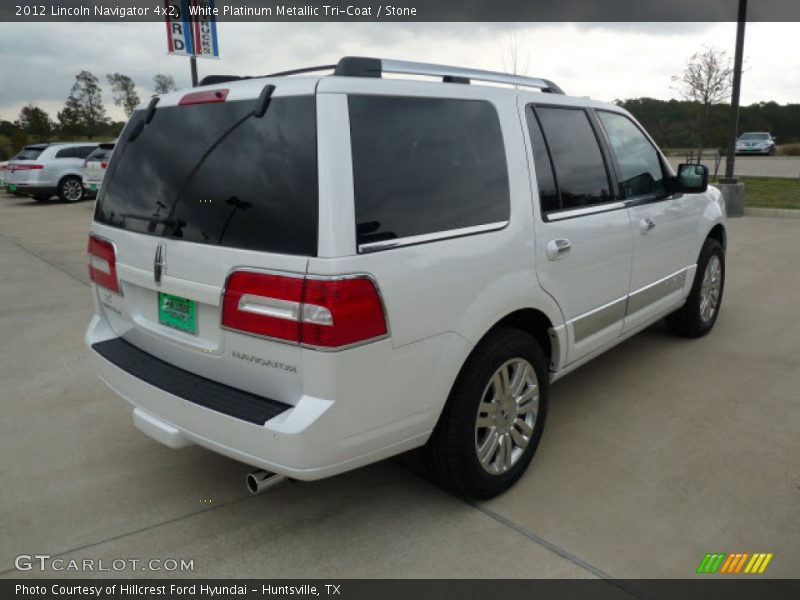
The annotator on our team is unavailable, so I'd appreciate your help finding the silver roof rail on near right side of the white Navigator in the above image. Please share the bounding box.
[333,56,564,94]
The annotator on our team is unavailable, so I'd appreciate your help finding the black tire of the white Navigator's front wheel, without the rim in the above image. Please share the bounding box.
[667,238,725,338]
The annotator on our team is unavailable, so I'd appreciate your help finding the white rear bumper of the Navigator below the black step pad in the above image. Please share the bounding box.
[85,316,438,480]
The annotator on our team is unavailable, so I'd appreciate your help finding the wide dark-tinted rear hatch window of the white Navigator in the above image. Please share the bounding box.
[95,96,318,256]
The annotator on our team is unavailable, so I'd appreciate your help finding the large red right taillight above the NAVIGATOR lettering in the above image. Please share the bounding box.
[222,271,387,348]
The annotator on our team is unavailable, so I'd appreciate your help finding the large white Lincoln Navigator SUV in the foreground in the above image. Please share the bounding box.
[86,57,726,497]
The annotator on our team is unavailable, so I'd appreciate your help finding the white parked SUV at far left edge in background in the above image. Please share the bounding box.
[4,143,97,202]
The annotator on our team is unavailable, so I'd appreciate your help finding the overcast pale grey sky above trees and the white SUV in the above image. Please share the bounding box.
[0,23,800,120]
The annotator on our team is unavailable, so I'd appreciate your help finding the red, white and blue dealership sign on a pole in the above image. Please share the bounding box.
[164,0,219,58]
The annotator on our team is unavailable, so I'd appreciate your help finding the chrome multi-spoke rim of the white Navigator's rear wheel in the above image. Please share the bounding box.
[475,358,539,475]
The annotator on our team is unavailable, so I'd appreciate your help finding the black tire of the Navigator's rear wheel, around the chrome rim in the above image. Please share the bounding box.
[425,328,550,498]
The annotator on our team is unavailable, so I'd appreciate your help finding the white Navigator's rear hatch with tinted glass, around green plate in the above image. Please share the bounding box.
[93,81,318,404]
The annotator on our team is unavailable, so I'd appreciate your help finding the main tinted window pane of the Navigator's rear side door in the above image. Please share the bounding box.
[536,107,613,208]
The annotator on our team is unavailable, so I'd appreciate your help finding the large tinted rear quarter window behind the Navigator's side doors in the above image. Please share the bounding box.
[348,96,510,245]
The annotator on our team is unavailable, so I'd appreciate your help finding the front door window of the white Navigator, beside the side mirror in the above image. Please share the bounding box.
[597,111,667,198]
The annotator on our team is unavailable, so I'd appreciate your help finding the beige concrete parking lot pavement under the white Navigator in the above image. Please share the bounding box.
[0,194,800,578]
